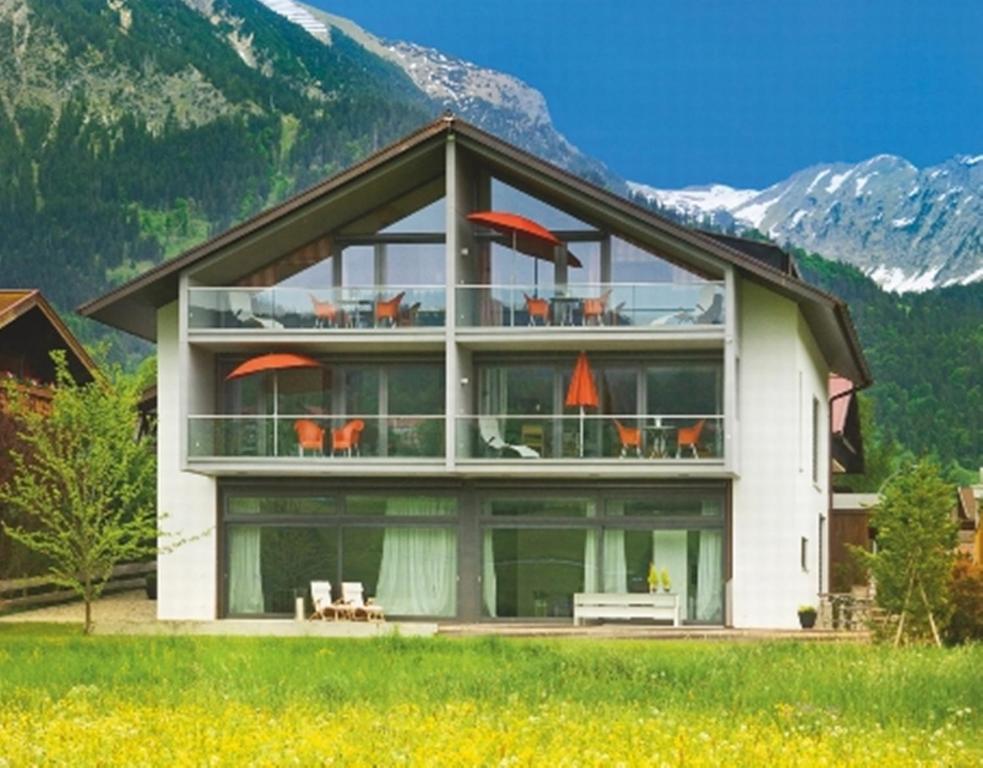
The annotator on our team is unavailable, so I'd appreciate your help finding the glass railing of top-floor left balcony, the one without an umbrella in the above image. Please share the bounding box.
[188,285,446,331]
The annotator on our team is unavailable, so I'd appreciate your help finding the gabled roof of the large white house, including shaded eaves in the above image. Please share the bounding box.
[79,115,871,387]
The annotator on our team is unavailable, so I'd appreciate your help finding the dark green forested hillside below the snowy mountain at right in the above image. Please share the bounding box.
[793,250,983,480]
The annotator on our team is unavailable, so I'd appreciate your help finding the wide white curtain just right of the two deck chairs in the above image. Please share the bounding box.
[376,497,457,616]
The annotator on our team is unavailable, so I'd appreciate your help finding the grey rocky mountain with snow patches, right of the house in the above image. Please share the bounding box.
[629,155,983,291]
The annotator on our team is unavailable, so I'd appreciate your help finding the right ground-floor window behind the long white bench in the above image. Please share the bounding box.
[481,490,724,624]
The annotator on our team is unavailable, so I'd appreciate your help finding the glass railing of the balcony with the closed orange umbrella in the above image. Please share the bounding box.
[457,414,723,461]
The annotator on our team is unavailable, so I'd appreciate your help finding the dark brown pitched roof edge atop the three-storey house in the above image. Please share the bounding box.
[78,115,871,387]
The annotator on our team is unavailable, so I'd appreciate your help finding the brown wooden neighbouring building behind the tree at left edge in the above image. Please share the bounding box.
[0,290,96,578]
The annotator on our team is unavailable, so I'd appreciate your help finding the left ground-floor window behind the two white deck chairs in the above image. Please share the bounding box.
[225,493,458,616]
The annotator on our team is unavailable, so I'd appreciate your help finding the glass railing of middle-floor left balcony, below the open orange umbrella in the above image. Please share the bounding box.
[188,415,444,460]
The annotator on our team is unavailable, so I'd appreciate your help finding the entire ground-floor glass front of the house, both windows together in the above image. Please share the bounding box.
[223,483,727,624]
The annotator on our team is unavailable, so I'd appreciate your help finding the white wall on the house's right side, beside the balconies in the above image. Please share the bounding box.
[731,281,829,628]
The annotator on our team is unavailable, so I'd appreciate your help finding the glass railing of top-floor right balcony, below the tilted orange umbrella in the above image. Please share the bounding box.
[457,283,724,329]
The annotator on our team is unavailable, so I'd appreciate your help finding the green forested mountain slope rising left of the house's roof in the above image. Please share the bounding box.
[0,0,434,360]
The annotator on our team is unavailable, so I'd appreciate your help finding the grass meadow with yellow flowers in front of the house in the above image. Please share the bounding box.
[0,624,983,768]
